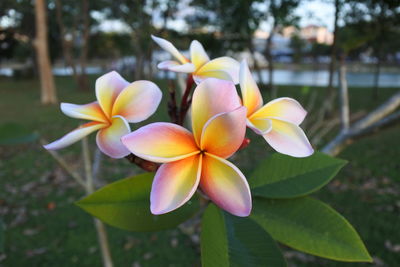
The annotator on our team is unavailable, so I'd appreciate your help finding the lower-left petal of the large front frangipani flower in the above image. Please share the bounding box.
[150,155,202,214]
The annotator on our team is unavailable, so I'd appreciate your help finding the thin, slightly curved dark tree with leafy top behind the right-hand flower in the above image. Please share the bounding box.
[265,0,300,98]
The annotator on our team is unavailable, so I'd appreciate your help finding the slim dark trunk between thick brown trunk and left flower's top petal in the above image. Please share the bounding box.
[79,0,89,90]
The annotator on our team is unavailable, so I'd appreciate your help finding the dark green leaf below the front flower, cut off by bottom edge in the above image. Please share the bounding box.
[201,204,286,267]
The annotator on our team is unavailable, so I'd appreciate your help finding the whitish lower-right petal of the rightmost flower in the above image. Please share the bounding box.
[264,119,314,158]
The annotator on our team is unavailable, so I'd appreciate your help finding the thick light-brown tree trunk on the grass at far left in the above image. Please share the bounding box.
[34,0,57,104]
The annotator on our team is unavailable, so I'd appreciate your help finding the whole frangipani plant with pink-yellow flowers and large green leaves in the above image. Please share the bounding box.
[45,34,371,267]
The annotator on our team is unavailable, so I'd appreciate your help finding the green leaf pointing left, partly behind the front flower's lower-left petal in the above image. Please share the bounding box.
[76,173,199,232]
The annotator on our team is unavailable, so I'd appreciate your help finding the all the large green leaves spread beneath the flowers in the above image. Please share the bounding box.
[78,150,371,266]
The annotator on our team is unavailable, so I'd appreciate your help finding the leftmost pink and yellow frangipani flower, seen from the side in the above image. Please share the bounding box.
[44,71,162,158]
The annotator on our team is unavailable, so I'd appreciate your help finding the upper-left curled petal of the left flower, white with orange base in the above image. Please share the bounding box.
[61,101,108,123]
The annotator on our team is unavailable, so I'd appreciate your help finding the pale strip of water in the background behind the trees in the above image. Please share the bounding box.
[0,67,400,87]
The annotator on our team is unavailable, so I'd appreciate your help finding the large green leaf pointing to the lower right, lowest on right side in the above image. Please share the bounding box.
[251,197,372,262]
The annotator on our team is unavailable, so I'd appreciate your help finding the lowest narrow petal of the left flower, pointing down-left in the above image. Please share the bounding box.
[43,122,107,150]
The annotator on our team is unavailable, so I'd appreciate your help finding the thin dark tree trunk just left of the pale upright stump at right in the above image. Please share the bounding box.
[325,0,340,114]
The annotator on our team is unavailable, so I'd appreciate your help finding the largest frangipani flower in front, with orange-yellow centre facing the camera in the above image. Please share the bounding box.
[122,78,251,216]
